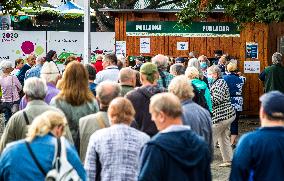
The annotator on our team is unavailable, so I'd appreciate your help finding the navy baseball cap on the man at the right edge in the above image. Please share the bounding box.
[259,91,284,119]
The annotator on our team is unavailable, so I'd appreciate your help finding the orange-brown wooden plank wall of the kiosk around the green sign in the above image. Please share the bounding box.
[115,13,270,115]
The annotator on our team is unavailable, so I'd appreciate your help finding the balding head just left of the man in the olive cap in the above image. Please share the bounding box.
[119,67,136,86]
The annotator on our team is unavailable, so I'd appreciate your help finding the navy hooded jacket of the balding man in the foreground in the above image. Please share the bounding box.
[138,130,211,181]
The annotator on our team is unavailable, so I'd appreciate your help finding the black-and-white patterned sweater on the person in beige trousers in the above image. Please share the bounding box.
[210,79,235,124]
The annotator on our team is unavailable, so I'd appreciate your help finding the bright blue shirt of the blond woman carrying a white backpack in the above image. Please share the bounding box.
[0,134,86,181]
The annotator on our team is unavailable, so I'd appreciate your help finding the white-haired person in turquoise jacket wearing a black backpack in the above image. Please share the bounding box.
[185,67,212,113]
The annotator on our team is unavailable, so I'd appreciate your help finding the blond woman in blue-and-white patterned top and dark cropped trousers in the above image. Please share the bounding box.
[223,62,246,148]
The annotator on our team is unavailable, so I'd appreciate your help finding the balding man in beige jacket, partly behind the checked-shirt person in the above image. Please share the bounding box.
[79,81,121,162]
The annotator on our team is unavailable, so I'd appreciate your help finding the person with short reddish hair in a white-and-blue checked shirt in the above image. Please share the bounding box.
[85,97,150,180]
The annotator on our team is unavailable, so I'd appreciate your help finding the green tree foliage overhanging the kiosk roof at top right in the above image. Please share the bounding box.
[178,0,284,23]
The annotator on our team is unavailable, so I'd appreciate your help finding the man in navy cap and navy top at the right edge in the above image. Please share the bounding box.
[230,91,284,181]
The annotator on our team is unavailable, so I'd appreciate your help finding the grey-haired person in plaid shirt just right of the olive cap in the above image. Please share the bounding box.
[152,54,174,89]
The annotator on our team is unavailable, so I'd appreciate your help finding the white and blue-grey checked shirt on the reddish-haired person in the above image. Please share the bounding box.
[85,124,150,181]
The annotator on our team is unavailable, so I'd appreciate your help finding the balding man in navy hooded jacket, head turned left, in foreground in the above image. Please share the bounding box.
[138,93,211,181]
